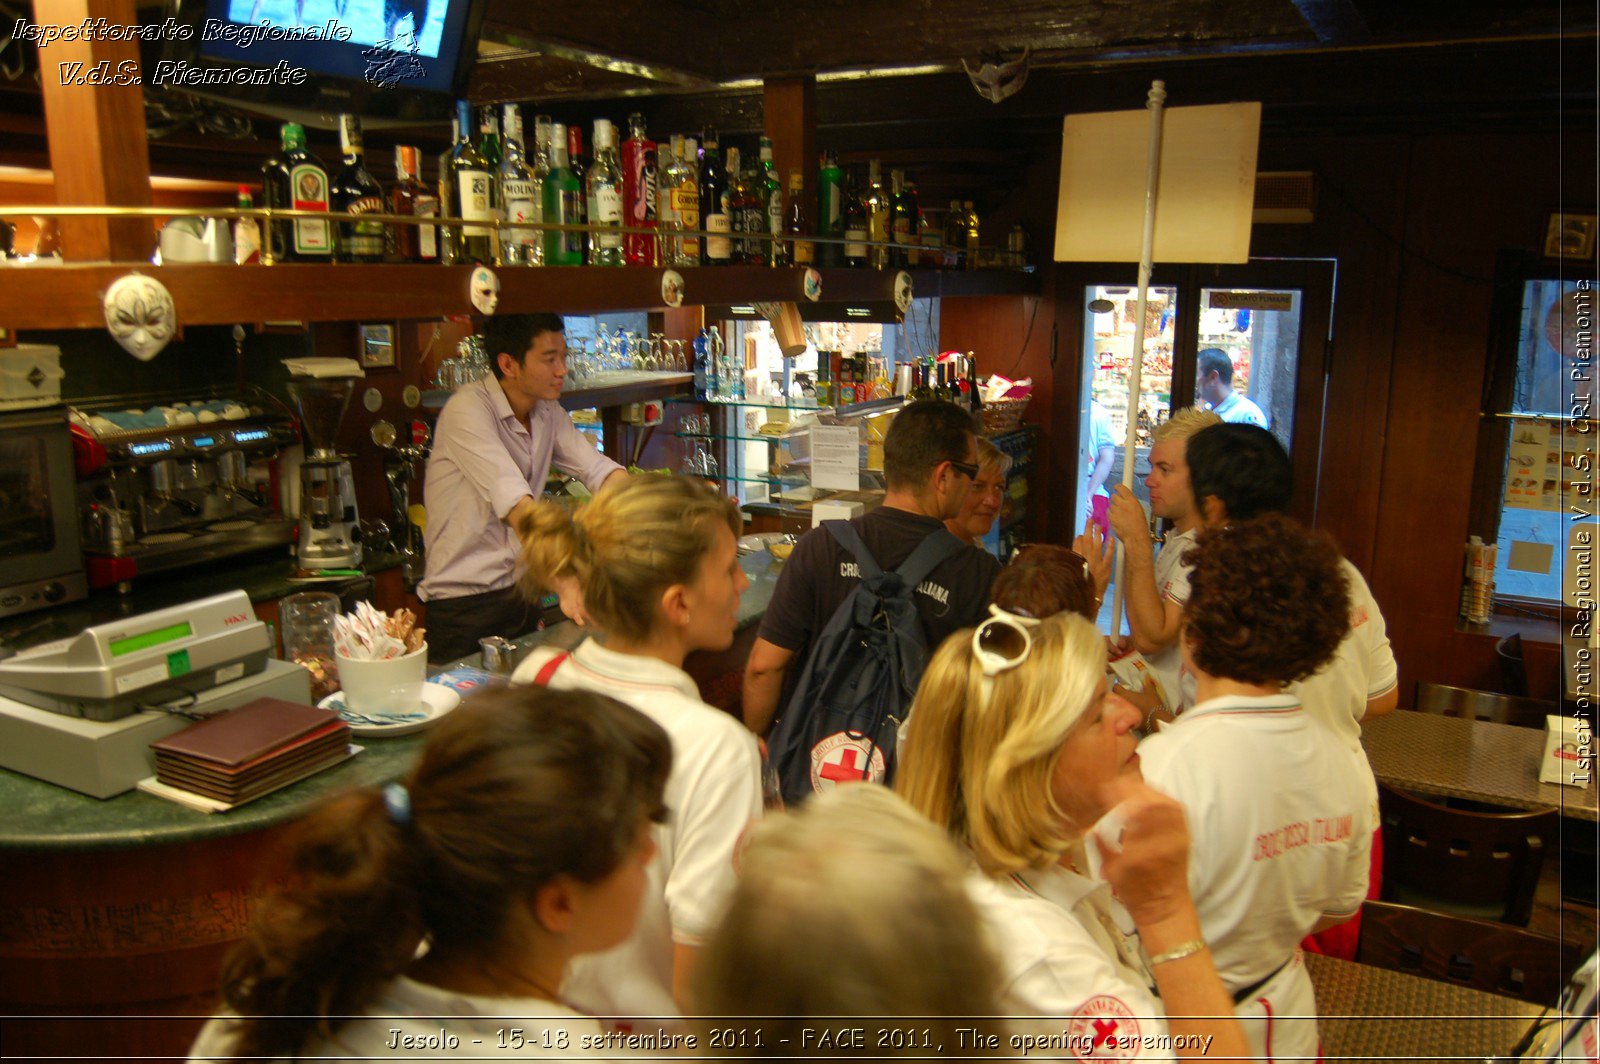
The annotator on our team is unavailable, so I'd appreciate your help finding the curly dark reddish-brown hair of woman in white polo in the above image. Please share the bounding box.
[1184,514,1350,683]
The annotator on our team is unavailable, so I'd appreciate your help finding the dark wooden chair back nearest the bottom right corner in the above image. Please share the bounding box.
[1355,901,1586,1005]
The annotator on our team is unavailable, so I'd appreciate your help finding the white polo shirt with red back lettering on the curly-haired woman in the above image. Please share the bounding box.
[1139,694,1376,1054]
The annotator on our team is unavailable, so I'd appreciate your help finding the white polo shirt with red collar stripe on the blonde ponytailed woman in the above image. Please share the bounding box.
[512,638,762,1018]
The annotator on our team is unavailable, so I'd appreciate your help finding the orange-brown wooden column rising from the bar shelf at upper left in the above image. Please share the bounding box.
[34,0,154,262]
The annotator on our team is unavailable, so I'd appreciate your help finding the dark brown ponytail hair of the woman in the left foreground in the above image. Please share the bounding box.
[222,686,672,1058]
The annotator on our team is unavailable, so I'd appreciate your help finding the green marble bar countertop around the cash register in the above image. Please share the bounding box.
[0,550,781,853]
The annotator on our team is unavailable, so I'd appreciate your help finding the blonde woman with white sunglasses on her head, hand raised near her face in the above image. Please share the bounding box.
[894,606,1248,1061]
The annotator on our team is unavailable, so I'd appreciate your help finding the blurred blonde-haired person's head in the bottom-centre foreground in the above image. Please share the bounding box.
[694,786,1000,1056]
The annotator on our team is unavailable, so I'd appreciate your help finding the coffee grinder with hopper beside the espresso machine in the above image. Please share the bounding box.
[283,358,363,570]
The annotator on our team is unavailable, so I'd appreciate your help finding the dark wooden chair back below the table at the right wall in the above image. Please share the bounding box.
[1378,781,1560,926]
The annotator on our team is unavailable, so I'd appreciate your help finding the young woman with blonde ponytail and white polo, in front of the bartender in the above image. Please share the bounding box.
[512,475,762,1018]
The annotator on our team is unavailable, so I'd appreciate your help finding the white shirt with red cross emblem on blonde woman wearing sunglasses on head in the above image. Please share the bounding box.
[966,866,1173,1061]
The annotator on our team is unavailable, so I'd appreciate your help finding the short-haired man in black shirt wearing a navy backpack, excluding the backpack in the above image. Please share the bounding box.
[744,400,1000,745]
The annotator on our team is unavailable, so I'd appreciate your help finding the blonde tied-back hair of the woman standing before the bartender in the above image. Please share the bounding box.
[517,474,744,640]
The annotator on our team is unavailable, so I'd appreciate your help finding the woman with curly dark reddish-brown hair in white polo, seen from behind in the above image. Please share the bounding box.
[1139,514,1374,1059]
